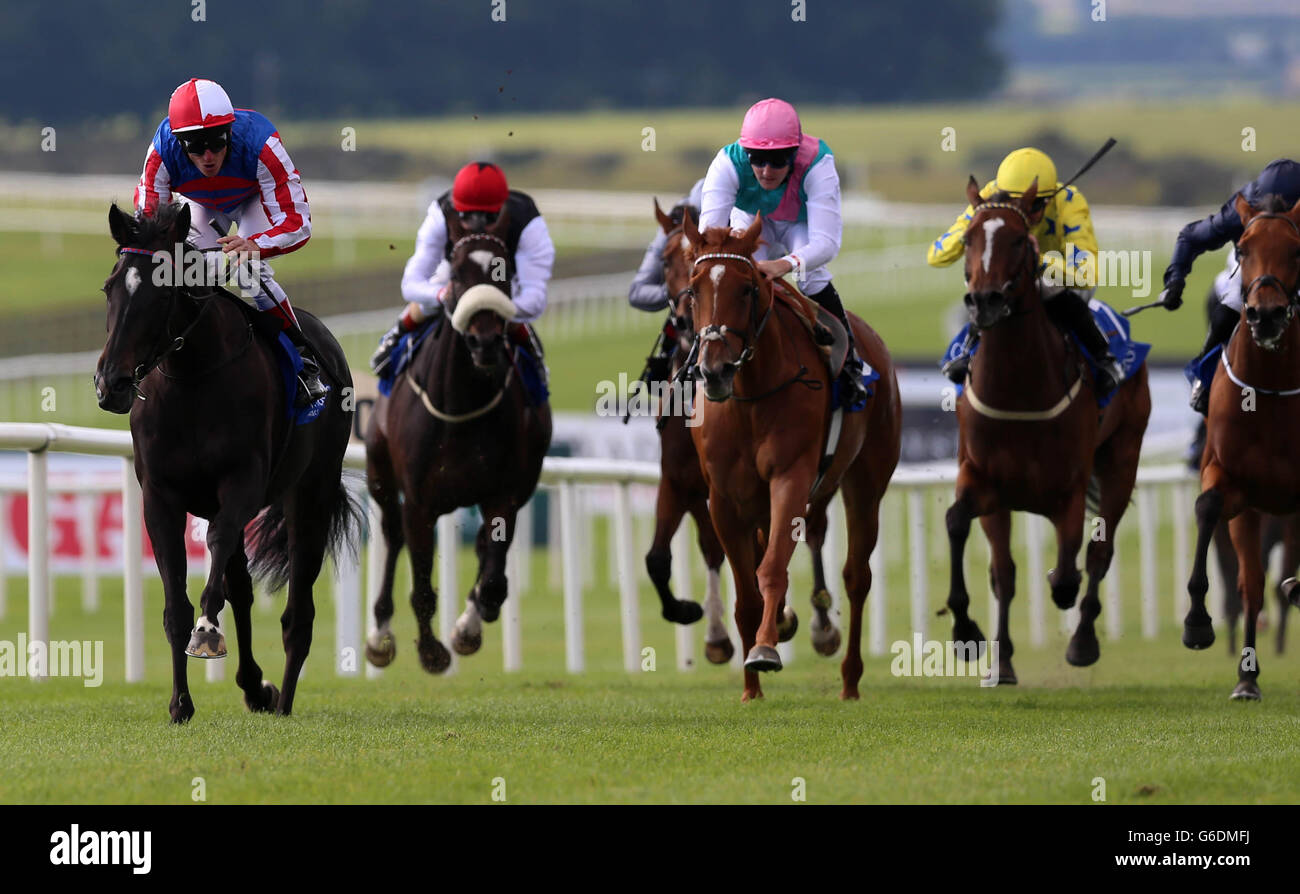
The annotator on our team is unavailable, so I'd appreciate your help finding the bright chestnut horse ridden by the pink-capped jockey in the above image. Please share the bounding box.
[683,213,902,700]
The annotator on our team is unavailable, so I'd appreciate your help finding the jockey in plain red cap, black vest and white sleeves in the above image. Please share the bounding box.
[371,161,555,376]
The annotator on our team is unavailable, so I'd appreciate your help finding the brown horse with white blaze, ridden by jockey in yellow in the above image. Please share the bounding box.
[946,177,1151,683]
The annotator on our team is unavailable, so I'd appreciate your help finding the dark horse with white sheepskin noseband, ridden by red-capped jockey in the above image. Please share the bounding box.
[365,212,551,673]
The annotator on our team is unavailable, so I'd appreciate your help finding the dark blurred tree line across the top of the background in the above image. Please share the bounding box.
[0,0,1005,123]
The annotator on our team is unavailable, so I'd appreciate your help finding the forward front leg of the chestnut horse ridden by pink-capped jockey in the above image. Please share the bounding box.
[745,463,816,671]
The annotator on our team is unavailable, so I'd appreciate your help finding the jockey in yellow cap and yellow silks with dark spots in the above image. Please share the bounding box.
[926,148,1125,391]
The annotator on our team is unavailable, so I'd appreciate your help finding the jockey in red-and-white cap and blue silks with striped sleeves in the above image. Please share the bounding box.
[135,78,325,400]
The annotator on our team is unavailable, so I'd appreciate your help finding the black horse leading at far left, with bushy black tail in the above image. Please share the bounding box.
[95,204,361,722]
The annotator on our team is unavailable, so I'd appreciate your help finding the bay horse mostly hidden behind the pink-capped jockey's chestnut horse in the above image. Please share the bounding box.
[646,199,840,664]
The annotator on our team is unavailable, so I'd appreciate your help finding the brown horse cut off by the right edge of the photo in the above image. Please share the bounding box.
[1183,195,1300,700]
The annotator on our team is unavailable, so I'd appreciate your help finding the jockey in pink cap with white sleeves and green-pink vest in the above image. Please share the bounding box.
[699,99,868,407]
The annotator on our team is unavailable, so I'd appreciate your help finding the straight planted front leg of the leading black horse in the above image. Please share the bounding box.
[144,481,194,724]
